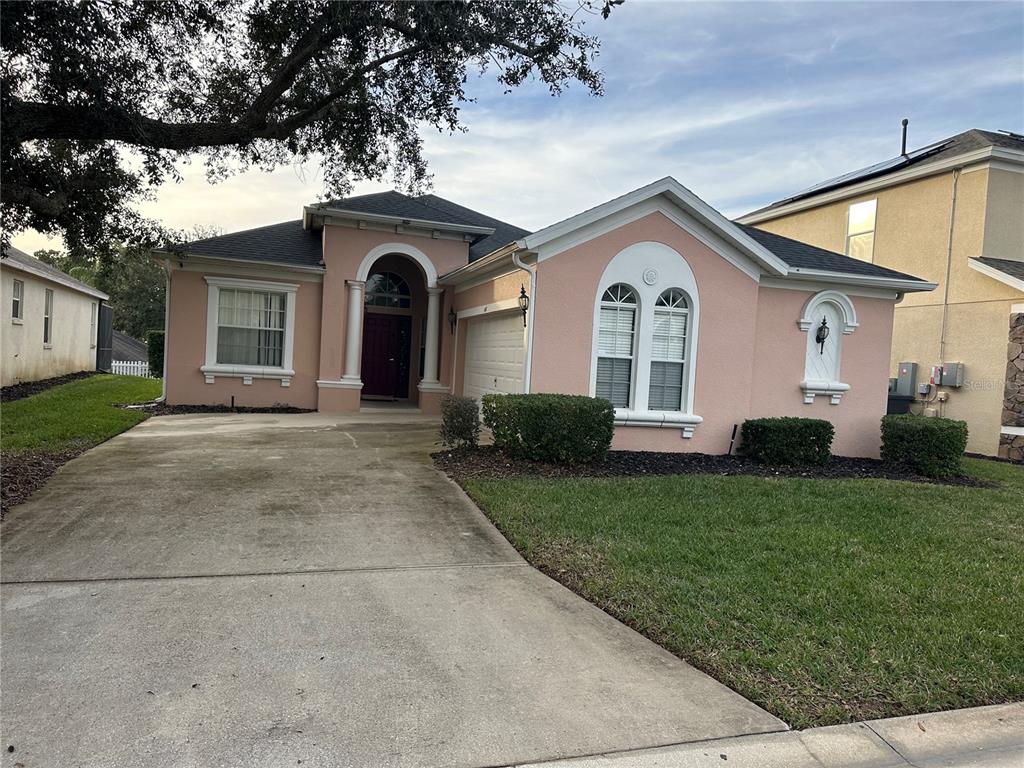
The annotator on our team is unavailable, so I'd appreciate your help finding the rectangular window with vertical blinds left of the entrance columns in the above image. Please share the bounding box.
[217,288,285,368]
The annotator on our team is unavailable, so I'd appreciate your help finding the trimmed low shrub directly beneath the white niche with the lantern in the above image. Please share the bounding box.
[741,416,836,467]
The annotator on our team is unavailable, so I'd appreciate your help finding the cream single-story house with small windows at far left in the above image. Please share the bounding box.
[0,248,108,386]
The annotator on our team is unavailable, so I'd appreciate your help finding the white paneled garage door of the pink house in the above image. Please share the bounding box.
[463,312,526,398]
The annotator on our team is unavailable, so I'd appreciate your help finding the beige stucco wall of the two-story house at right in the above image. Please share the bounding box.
[757,160,1024,456]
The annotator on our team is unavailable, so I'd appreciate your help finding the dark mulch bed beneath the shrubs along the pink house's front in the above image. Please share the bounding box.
[432,446,992,487]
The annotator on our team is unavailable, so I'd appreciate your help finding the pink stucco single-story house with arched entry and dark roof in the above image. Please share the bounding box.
[159,178,934,456]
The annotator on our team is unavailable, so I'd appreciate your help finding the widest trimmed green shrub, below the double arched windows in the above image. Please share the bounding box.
[483,394,615,464]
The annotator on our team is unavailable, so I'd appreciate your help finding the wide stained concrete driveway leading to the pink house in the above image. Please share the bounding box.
[0,414,785,768]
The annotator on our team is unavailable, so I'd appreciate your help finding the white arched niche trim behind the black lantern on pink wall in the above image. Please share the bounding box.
[797,291,857,406]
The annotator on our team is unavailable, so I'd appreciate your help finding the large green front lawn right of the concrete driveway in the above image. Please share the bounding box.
[465,460,1024,727]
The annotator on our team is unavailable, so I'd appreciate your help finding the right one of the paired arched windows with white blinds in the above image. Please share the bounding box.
[647,288,690,411]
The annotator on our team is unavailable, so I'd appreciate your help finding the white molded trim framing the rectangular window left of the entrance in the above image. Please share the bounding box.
[200,275,299,387]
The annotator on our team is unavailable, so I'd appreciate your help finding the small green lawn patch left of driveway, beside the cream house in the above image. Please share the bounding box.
[0,374,161,455]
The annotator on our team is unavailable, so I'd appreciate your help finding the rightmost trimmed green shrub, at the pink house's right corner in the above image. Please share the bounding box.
[882,414,967,477]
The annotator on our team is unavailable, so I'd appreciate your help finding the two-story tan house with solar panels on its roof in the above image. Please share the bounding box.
[739,130,1024,459]
